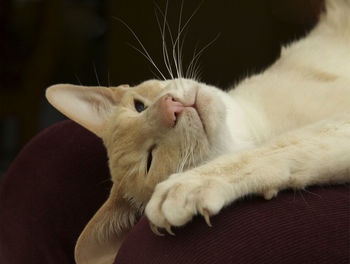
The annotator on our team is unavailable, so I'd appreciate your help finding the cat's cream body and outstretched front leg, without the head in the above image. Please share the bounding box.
[146,0,350,228]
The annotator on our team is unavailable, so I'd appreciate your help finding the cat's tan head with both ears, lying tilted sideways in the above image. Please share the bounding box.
[46,79,229,264]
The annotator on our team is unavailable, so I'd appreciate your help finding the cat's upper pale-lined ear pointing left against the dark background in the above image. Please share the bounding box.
[46,84,130,137]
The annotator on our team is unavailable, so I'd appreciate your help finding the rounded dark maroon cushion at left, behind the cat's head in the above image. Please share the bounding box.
[0,121,110,264]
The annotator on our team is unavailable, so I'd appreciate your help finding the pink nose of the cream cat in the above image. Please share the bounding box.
[160,95,184,127]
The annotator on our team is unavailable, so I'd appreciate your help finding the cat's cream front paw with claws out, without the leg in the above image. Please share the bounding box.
[145,172,232,232]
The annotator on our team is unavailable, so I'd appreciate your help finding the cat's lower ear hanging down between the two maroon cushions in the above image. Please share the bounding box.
[75,188,137,264]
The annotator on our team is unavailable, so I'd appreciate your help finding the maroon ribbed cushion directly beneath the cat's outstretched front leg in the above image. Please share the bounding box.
[115,185,350,264]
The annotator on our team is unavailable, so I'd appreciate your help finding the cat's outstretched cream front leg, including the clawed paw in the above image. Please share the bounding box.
[146,117,350,230]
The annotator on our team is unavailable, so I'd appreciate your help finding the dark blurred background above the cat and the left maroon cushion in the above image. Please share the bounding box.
[0,0,322,177]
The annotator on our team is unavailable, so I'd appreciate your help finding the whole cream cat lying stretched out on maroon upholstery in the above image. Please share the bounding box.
[46,0,350,264]
